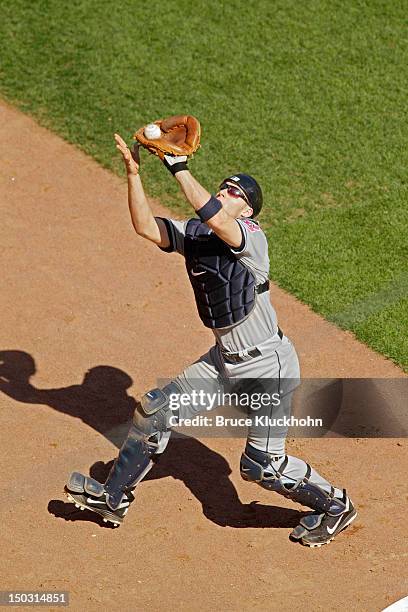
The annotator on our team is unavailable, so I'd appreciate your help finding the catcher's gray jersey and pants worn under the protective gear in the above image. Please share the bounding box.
[158,219,342,498]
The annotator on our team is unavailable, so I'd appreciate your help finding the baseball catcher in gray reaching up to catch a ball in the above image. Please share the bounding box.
[65,116,357,546]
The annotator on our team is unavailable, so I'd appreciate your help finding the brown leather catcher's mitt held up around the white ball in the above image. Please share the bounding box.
[134,115,201,159]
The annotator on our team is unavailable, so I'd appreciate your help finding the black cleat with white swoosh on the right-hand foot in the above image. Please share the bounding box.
[289,491,357,547]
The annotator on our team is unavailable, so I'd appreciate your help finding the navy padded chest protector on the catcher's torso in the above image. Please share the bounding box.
[184,219,269,329]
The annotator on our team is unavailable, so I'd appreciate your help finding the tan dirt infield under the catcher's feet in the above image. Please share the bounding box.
[0,104,408,611]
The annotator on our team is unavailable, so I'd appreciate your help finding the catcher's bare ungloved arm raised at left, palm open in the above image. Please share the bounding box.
[115,134,170,248]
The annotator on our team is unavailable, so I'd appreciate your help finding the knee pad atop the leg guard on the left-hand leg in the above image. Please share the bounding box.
[133,381,182,454]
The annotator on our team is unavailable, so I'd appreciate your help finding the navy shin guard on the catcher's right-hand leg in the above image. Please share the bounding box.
[241,445,346,516]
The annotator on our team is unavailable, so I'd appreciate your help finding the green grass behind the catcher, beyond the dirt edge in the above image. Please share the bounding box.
[0,0,408,371]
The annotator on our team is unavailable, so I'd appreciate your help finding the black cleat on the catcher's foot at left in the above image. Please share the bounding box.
[64,472,134,527]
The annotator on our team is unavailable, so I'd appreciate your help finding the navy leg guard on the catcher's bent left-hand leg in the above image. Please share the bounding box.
[105,382,181,510]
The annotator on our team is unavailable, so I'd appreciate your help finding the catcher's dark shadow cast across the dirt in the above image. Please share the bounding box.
[0,351,303,527]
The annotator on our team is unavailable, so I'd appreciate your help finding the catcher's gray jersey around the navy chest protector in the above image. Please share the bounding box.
[158,219,277,353]
